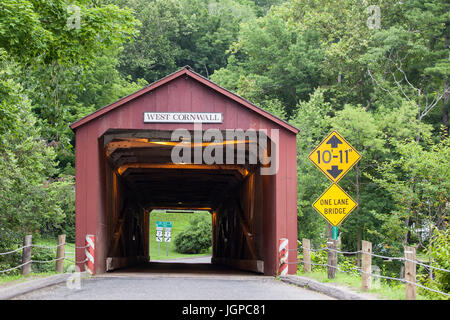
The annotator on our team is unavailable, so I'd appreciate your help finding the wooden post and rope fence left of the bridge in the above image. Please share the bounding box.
[0,235,90,275]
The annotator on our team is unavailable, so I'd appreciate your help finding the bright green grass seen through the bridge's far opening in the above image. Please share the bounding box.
[149,210,212,260]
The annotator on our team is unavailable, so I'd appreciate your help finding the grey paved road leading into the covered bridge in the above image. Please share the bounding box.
[16,258,333,300]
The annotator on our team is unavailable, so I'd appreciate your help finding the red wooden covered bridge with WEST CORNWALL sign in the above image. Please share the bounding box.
[71,67,298,275]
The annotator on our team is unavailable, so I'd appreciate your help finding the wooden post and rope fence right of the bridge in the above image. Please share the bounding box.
[287,239,450,300]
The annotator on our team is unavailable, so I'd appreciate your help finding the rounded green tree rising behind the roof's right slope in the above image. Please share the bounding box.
[211,7,323,117]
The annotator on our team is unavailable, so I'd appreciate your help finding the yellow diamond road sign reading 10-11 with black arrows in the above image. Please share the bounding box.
[308,131,361,183]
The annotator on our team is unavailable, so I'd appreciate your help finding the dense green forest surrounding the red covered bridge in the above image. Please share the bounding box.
[0,0,450,291]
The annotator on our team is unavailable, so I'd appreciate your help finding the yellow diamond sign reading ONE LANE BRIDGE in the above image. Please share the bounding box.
[313,183,358,227]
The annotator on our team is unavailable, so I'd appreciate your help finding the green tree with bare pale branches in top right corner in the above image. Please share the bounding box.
[359,0,450,136]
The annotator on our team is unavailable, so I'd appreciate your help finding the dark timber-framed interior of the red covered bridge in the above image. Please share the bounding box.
[101,130,274,273]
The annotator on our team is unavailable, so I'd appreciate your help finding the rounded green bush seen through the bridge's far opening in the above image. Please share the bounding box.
[175,217,212,253]
